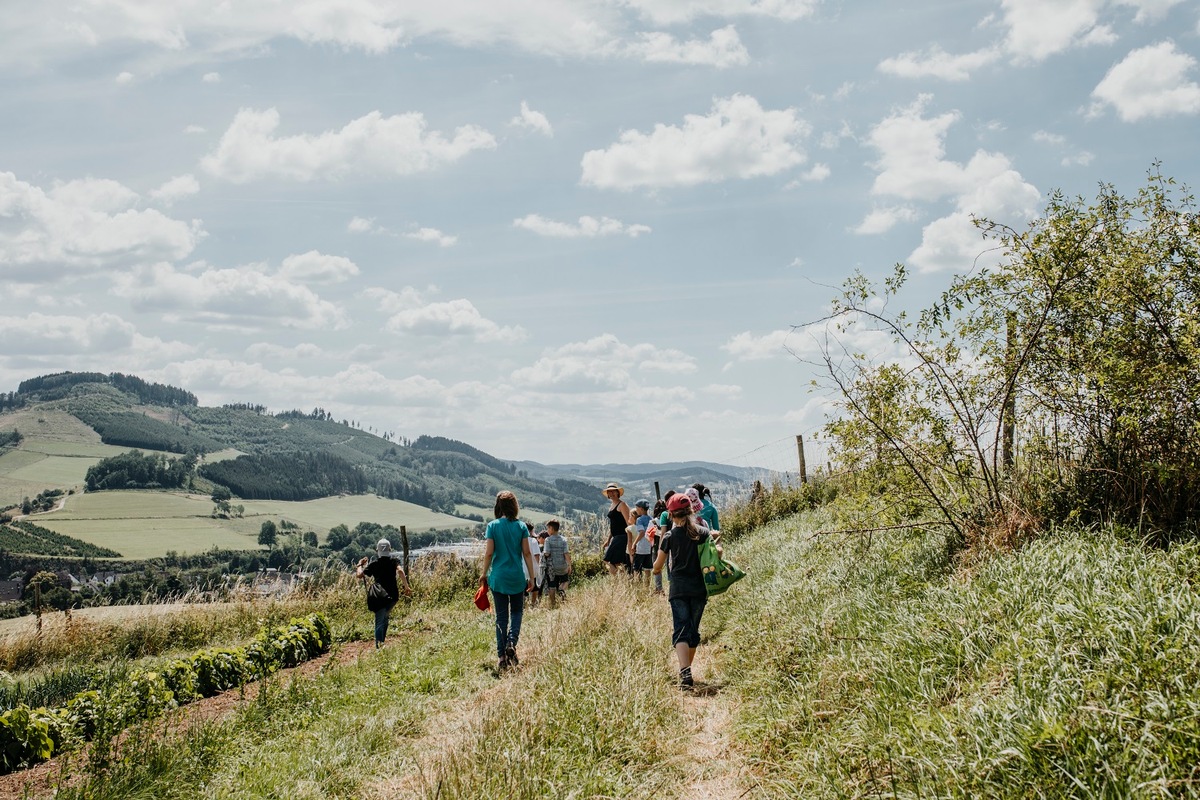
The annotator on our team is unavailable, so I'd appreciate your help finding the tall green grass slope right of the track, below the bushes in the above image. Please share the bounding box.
[713,516,1200,798]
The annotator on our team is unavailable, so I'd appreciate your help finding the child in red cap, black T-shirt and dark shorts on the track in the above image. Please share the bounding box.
[654,494,709,691]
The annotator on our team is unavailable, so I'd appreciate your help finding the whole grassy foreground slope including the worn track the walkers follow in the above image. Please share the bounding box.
[9,516,1200,798]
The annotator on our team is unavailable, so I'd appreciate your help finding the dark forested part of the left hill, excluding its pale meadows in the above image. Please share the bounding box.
[0,373,600,519]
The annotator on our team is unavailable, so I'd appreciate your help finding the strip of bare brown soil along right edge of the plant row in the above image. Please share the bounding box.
[0,642,374,800]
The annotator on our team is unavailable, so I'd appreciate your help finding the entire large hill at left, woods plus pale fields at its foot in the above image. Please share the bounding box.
[0,373,609,559]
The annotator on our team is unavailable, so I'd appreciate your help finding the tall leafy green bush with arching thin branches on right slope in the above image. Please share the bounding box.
[823,164,1200,541]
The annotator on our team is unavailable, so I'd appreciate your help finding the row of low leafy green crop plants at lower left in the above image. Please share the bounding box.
[0,613,331,775]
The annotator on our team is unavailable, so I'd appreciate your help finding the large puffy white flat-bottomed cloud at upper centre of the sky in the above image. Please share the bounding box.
[581,95,810,190]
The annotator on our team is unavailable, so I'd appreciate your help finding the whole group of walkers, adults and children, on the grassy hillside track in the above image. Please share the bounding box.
[356,483,720,690]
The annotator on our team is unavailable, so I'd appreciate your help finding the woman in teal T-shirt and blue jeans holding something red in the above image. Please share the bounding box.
[479,492,534,672]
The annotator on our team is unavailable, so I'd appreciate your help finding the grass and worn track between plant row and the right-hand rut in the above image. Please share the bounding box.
[44,583,686,800]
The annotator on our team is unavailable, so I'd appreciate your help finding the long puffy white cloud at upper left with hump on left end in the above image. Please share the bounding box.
[200,108,496,184]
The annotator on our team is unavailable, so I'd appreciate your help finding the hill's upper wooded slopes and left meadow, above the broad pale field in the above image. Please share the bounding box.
[0,373,599,522]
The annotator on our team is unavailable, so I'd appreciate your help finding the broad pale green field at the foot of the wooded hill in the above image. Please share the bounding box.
[30,492,474,559]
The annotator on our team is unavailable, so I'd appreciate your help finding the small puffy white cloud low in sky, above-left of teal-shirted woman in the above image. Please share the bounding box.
[366,287,527,343]
